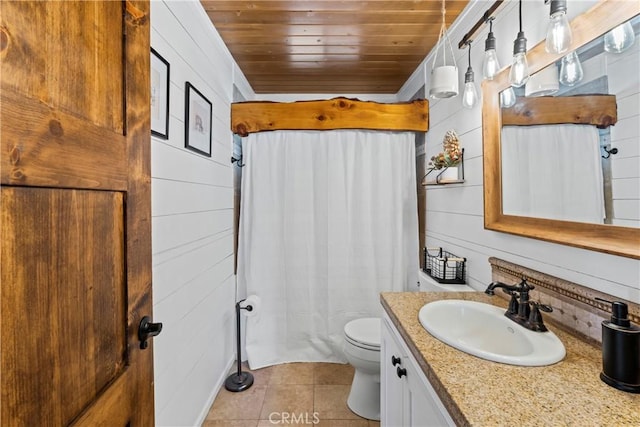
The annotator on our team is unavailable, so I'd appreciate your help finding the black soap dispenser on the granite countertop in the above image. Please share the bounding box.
[596,298,640,393]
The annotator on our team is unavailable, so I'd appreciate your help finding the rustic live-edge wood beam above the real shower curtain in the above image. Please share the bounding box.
[231,98,429,136]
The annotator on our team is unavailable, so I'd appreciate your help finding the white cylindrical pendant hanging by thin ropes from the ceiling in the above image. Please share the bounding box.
[429,0,458,99]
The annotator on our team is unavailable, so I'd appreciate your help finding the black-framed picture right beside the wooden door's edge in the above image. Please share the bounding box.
[151,48,169,139]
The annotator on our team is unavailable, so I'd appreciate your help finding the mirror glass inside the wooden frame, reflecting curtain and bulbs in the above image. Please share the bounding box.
[500,16,640,227]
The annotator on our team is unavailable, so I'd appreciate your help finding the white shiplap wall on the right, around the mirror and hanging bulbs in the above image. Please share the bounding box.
[398,0,640,302]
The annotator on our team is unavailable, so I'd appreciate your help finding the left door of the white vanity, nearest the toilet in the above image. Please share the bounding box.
[380,320,406,427]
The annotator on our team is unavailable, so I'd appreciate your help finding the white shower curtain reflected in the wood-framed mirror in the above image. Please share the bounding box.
[502,125,605,224]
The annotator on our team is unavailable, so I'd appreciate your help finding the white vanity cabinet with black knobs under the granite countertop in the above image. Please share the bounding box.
[380,313,455,427]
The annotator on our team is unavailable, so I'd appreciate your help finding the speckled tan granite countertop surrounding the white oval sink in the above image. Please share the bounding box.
[380,292,640,426]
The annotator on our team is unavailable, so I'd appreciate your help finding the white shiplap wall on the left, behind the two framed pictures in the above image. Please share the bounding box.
[151,1,253,426]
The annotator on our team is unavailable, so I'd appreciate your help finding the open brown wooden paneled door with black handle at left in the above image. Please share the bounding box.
[0,0,154,427]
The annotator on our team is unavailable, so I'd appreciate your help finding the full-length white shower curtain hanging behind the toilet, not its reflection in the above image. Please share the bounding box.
[238,130,418,369]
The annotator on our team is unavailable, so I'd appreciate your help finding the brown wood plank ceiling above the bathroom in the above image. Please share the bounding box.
[201,0,469,94]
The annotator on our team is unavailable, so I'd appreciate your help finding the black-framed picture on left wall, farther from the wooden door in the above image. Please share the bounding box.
[184,82,213,157]
